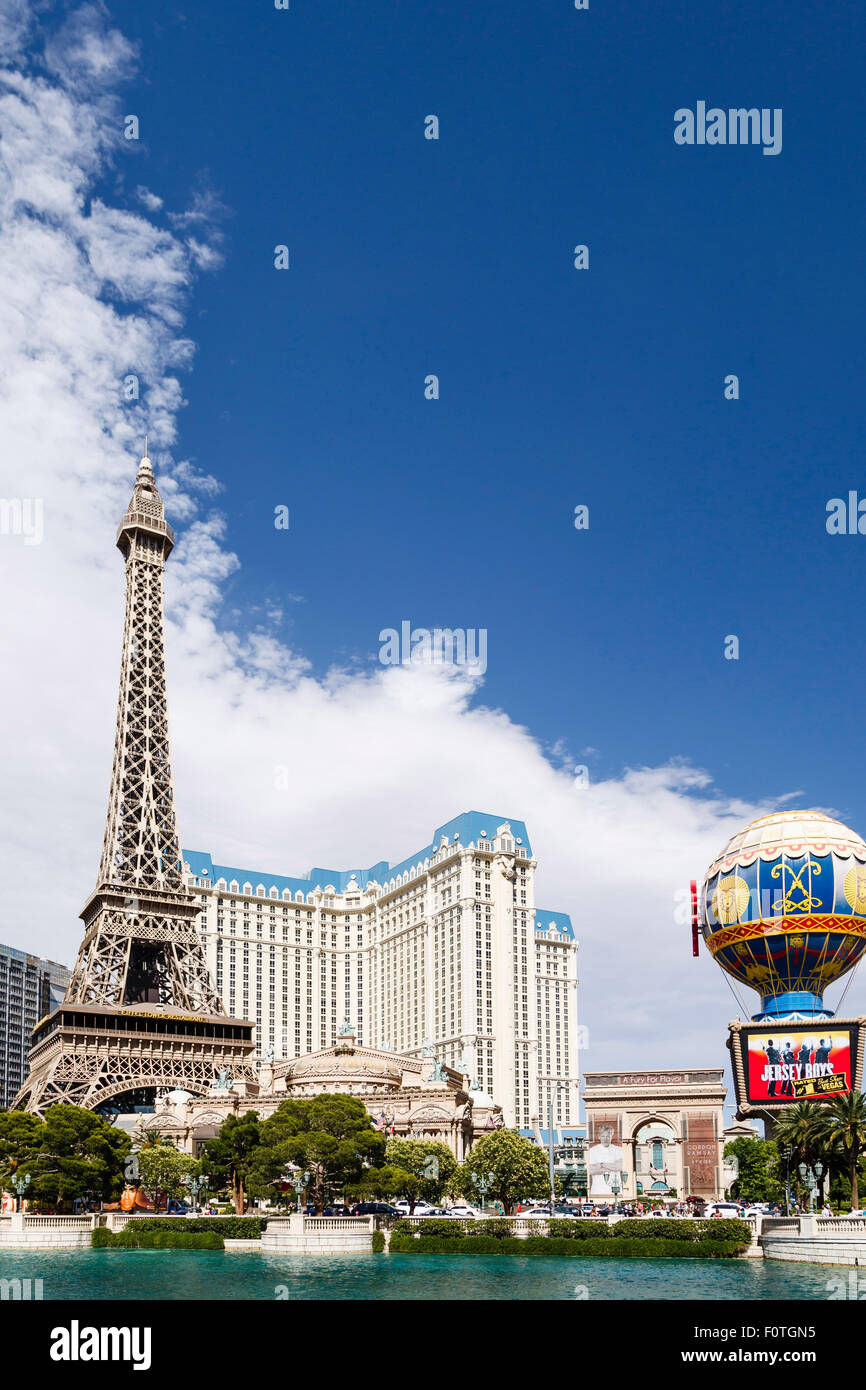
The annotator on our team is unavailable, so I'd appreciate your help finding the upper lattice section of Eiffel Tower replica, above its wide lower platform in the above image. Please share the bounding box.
[67,453,219,1013]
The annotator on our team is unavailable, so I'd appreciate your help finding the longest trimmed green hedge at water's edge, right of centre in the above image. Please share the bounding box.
[391,1233,744,1259]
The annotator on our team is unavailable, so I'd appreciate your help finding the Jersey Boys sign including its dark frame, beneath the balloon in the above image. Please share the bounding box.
[730,1019,863,1113]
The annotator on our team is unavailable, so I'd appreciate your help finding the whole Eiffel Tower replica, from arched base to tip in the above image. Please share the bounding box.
[14,443,256,1113]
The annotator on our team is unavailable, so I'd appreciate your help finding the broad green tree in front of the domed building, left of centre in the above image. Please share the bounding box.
[257,1094,385,1212]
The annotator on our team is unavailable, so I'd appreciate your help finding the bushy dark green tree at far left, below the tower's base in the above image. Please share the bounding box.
[0,1105,129,1208]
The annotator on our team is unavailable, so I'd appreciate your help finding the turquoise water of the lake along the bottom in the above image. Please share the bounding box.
[0,1250,840,1302]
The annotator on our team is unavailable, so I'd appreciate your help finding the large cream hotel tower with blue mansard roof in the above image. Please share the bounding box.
[182,812,578,1127]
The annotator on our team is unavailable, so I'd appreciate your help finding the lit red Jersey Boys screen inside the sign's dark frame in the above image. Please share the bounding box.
[748,1023,852,1104]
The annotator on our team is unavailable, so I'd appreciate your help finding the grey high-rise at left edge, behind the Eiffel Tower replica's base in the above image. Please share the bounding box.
[0,945,71,1109]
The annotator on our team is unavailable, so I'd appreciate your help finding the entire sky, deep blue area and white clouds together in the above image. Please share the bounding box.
[6,0,866,1070]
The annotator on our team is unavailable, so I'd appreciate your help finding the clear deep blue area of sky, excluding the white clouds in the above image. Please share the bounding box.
[94,0,866,811]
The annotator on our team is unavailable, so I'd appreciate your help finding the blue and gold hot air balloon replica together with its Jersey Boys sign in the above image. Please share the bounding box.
[692,810,866,1119]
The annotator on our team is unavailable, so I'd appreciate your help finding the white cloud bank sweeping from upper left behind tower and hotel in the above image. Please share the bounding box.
[0,0,856,1069]
